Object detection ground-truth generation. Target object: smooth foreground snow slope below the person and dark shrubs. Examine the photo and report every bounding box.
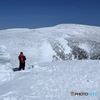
[0,60,100,100]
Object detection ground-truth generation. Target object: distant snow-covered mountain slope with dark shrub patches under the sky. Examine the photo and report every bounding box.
[0,24,100,66]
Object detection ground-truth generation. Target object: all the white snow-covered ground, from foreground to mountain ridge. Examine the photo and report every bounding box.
[0,24,100,100]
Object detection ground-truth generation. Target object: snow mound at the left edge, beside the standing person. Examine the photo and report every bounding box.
[0,45,12,83]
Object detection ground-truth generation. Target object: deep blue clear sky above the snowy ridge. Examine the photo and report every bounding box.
[0,0,100,30]
